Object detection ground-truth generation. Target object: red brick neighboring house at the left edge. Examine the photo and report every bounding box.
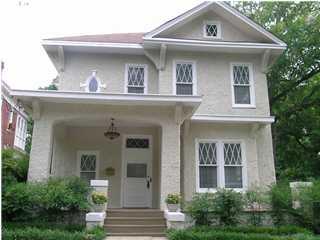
[1,81,28,151]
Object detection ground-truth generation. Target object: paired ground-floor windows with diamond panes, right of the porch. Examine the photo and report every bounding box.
[196,140,246,192]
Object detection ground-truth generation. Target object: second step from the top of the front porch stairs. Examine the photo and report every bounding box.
[105,217,166,226]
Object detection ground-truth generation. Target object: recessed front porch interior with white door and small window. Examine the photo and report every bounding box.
[49,117,162,208]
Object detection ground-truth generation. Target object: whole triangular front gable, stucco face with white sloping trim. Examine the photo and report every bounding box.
[144,2,286,46]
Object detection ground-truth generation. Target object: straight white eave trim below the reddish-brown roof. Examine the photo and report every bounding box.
[42,40,143,49]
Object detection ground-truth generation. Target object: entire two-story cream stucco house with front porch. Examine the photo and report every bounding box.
[11,2,286,209]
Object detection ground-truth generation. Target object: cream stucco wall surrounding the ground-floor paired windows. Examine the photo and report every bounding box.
[182,123,275,201]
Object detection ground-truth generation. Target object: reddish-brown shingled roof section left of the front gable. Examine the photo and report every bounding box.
[44,33,145,44]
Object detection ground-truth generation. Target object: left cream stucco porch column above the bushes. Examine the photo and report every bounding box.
[28,118,53,181]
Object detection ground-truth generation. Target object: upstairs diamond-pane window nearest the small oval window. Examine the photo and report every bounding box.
[125,64,148,94]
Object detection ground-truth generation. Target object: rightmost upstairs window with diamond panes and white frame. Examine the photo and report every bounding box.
[231,63,255,107]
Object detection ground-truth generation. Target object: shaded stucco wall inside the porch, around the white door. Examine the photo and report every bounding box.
[53,123,160,208]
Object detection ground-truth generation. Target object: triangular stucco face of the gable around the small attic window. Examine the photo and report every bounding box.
[159,10,270,42]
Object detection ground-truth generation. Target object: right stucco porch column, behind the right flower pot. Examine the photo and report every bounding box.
[160,122,180,210]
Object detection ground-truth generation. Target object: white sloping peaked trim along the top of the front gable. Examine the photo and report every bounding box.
[143,1,286,46]
